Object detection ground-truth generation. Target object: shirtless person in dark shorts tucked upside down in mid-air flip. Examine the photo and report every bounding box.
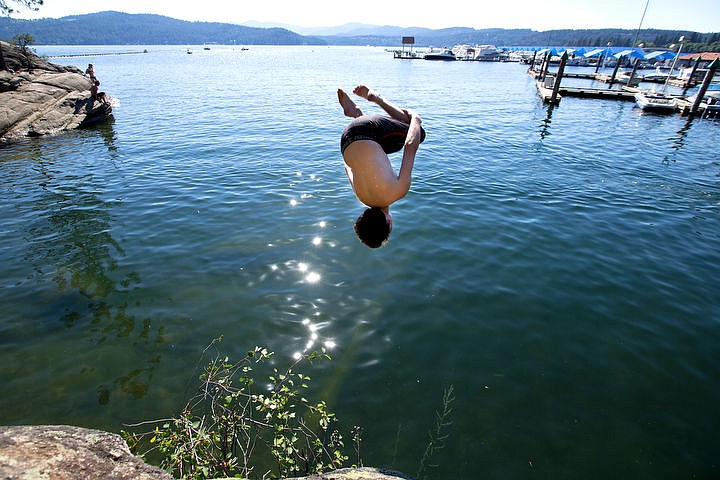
[337,85,425,248]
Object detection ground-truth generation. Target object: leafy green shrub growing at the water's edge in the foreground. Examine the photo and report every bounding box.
[122,339,360,479]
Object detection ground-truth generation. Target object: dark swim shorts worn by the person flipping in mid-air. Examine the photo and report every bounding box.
[340,115,425,153]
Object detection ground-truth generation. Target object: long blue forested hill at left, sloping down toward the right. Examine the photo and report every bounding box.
[0,12,325,45]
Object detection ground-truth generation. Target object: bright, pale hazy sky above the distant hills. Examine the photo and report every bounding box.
[13,0,720,32]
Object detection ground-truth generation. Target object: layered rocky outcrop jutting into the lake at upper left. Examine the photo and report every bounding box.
[0,42,112,143]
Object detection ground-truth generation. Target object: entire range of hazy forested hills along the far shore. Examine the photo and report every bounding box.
[0,12,720,51]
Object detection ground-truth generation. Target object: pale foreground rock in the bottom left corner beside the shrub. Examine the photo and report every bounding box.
[0,425,172,480]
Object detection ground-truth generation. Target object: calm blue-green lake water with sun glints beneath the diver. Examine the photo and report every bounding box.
[0,46,720,479]
